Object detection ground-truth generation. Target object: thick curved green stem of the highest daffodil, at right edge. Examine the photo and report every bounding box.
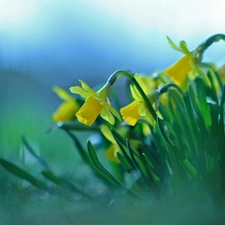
[193,34,225,63]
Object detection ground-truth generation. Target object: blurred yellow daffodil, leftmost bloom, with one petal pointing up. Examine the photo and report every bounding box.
[52,86,80,122]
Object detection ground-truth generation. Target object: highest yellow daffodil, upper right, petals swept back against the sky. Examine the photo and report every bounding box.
[164,37,196,86]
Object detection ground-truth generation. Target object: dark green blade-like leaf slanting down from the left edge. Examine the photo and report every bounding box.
[0,158,48,190]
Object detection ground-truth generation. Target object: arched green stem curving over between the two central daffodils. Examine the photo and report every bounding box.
[106,70,157,120]
